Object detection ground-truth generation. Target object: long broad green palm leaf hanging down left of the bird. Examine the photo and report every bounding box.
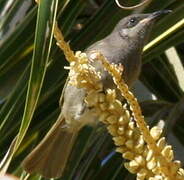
[15,0,58,150]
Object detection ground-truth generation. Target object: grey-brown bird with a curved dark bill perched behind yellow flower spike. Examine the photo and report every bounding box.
[22,10,170,178]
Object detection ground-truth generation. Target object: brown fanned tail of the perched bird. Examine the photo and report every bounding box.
[22,117,77,178]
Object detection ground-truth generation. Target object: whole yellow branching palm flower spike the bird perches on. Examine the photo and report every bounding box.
[55,25,184,180]
